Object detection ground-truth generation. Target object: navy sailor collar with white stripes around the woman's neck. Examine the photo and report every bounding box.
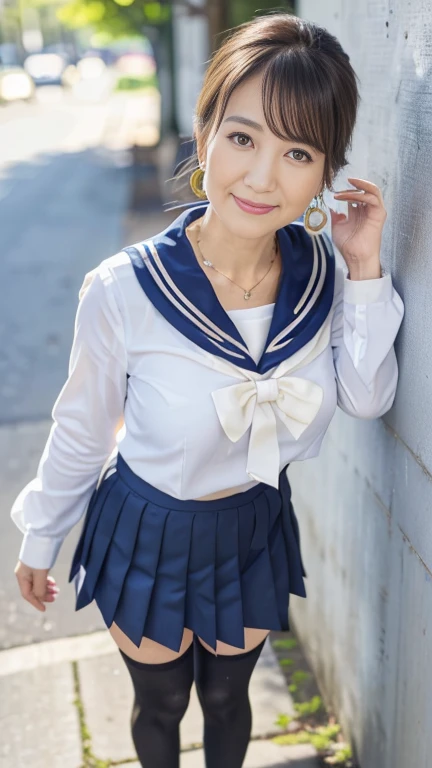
[123,201,335,374]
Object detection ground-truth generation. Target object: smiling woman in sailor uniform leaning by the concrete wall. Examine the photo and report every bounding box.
[12,14,403,768]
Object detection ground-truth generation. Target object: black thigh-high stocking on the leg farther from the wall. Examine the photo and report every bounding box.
[120,643,194,768]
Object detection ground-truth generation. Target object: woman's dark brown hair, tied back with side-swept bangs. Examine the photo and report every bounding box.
[177,13,360,195]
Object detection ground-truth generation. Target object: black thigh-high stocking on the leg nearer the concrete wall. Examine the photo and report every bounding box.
[194,638,265,768]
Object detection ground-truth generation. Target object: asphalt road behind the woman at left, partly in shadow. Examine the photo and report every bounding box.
[0,82,135,648]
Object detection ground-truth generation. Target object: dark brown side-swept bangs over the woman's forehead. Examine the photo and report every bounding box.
[262,49,335,155]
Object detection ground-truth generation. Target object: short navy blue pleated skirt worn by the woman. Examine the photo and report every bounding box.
[69,455,306,652]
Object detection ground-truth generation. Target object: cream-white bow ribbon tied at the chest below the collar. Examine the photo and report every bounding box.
[212,376,323,488]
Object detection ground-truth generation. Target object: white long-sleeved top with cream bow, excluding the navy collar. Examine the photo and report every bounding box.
[12,225,404,568]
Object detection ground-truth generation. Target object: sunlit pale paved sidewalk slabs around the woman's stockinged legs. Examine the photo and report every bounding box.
[0,631,319,768]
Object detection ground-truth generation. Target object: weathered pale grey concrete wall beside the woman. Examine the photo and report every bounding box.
[289,0,432,768]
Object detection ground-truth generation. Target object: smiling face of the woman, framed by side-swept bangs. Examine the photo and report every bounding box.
[198,75,325,238]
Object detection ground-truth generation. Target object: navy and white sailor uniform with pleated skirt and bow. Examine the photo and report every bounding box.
[12,202,404,651]
